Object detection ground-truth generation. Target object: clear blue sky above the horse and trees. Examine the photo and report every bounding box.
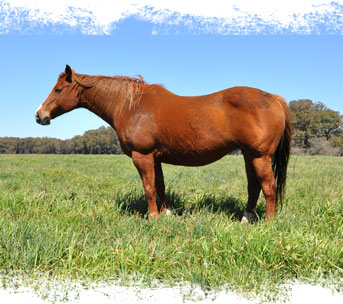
[0,0,343,138]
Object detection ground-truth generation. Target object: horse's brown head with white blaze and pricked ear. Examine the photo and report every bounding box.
[35,65,80,125]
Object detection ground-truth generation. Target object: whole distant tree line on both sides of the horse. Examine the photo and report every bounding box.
[0,99,343,156]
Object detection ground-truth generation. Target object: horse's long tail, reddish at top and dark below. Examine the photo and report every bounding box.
[272,96,292,206]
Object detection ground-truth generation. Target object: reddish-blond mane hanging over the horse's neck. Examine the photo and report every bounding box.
[73,73,146,113]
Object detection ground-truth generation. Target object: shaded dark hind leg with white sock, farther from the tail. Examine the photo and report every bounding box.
[241,153,261,223]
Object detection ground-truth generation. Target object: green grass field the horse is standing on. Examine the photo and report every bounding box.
[0,155,343,296]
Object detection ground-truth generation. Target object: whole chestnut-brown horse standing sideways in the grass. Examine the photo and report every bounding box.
[35,65,291,222]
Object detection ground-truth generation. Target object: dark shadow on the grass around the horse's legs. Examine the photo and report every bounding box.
[116,191,265,220]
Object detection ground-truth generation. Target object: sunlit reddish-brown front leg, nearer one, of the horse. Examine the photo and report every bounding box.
[131,152,158,218]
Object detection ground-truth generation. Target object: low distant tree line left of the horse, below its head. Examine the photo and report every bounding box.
[0,127,122,154]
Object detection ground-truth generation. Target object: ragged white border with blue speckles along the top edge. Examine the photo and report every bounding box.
[0,0,343,34]
